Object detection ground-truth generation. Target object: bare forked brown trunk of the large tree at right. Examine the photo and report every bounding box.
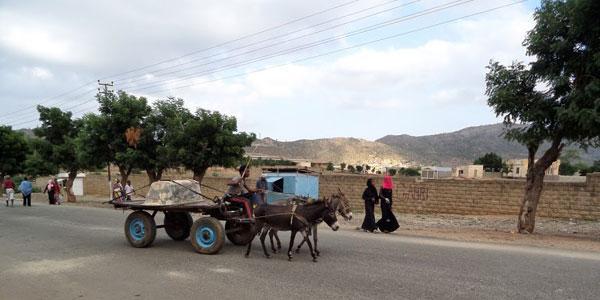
[517,139,564,233]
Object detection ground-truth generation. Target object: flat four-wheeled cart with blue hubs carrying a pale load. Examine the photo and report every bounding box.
[110,180,256,254]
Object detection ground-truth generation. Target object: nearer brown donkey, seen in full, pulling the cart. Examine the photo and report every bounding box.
[246,200,339,262]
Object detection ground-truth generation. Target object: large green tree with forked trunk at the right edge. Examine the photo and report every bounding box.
[486,0,600,232]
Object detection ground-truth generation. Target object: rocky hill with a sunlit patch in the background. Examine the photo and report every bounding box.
[248,124,600,166]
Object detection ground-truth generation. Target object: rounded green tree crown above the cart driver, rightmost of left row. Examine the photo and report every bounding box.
[174,109,256,182]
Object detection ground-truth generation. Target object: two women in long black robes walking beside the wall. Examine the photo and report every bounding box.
[361,175,400,233]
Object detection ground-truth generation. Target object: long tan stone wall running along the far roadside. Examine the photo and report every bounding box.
[84,174,600,219]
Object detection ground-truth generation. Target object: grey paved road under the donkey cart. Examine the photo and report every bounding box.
[0,204,600,299]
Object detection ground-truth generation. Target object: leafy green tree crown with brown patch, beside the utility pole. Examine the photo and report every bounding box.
[78,91,151,182]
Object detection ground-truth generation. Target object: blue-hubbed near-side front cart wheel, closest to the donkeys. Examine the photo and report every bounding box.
[190,217,225,254]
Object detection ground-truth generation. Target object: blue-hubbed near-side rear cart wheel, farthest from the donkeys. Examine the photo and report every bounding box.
[125,211,156,248]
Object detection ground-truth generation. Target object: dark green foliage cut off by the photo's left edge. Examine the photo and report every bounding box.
[0,126,30,177]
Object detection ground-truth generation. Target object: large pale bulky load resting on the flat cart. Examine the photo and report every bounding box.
[144,180,206,205]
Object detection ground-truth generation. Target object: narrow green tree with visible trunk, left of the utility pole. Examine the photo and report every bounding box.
[33,105,88,202]
